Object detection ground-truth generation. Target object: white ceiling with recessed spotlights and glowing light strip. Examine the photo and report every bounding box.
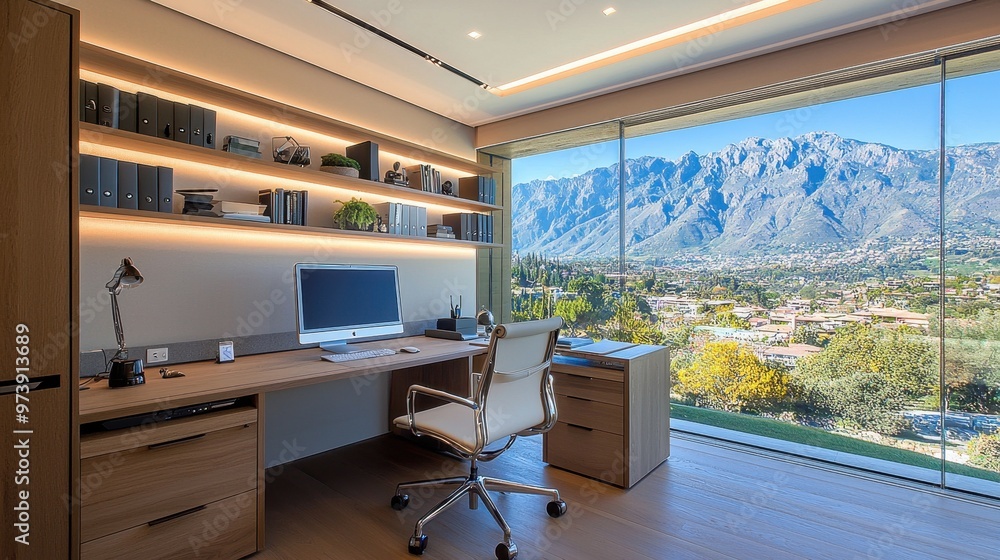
[146,0,966,126]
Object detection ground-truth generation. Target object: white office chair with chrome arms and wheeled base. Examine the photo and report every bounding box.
[391,317,566,560]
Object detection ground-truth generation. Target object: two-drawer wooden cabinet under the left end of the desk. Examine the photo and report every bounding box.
[79,406,259,560]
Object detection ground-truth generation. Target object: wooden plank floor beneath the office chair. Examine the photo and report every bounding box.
[253,435,1000,560]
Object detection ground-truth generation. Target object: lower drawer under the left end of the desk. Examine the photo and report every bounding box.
[80,491,257,560]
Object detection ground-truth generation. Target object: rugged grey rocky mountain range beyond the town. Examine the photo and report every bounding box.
[511,132,1000,257]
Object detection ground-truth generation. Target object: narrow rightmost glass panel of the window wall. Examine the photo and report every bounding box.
[939,51,1000,496]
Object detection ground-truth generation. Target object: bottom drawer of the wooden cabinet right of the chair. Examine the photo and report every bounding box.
[545,422,626,486]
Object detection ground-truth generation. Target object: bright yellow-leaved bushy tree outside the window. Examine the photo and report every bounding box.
[676,341,788,412]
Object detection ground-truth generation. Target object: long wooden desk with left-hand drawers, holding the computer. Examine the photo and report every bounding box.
[74,336,486,560]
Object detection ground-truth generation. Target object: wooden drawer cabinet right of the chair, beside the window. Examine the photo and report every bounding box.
[543,345,670,488]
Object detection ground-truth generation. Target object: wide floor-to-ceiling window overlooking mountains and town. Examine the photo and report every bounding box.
[494,43,1000,496]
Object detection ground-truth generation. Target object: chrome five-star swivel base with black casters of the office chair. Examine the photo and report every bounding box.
[390,468,566,560]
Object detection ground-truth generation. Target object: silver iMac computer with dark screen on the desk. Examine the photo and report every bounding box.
[295,263,403,354]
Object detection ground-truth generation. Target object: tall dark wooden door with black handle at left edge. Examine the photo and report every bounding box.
[0,0,79,559]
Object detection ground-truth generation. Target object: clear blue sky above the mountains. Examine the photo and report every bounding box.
[512,72,1000,184]
